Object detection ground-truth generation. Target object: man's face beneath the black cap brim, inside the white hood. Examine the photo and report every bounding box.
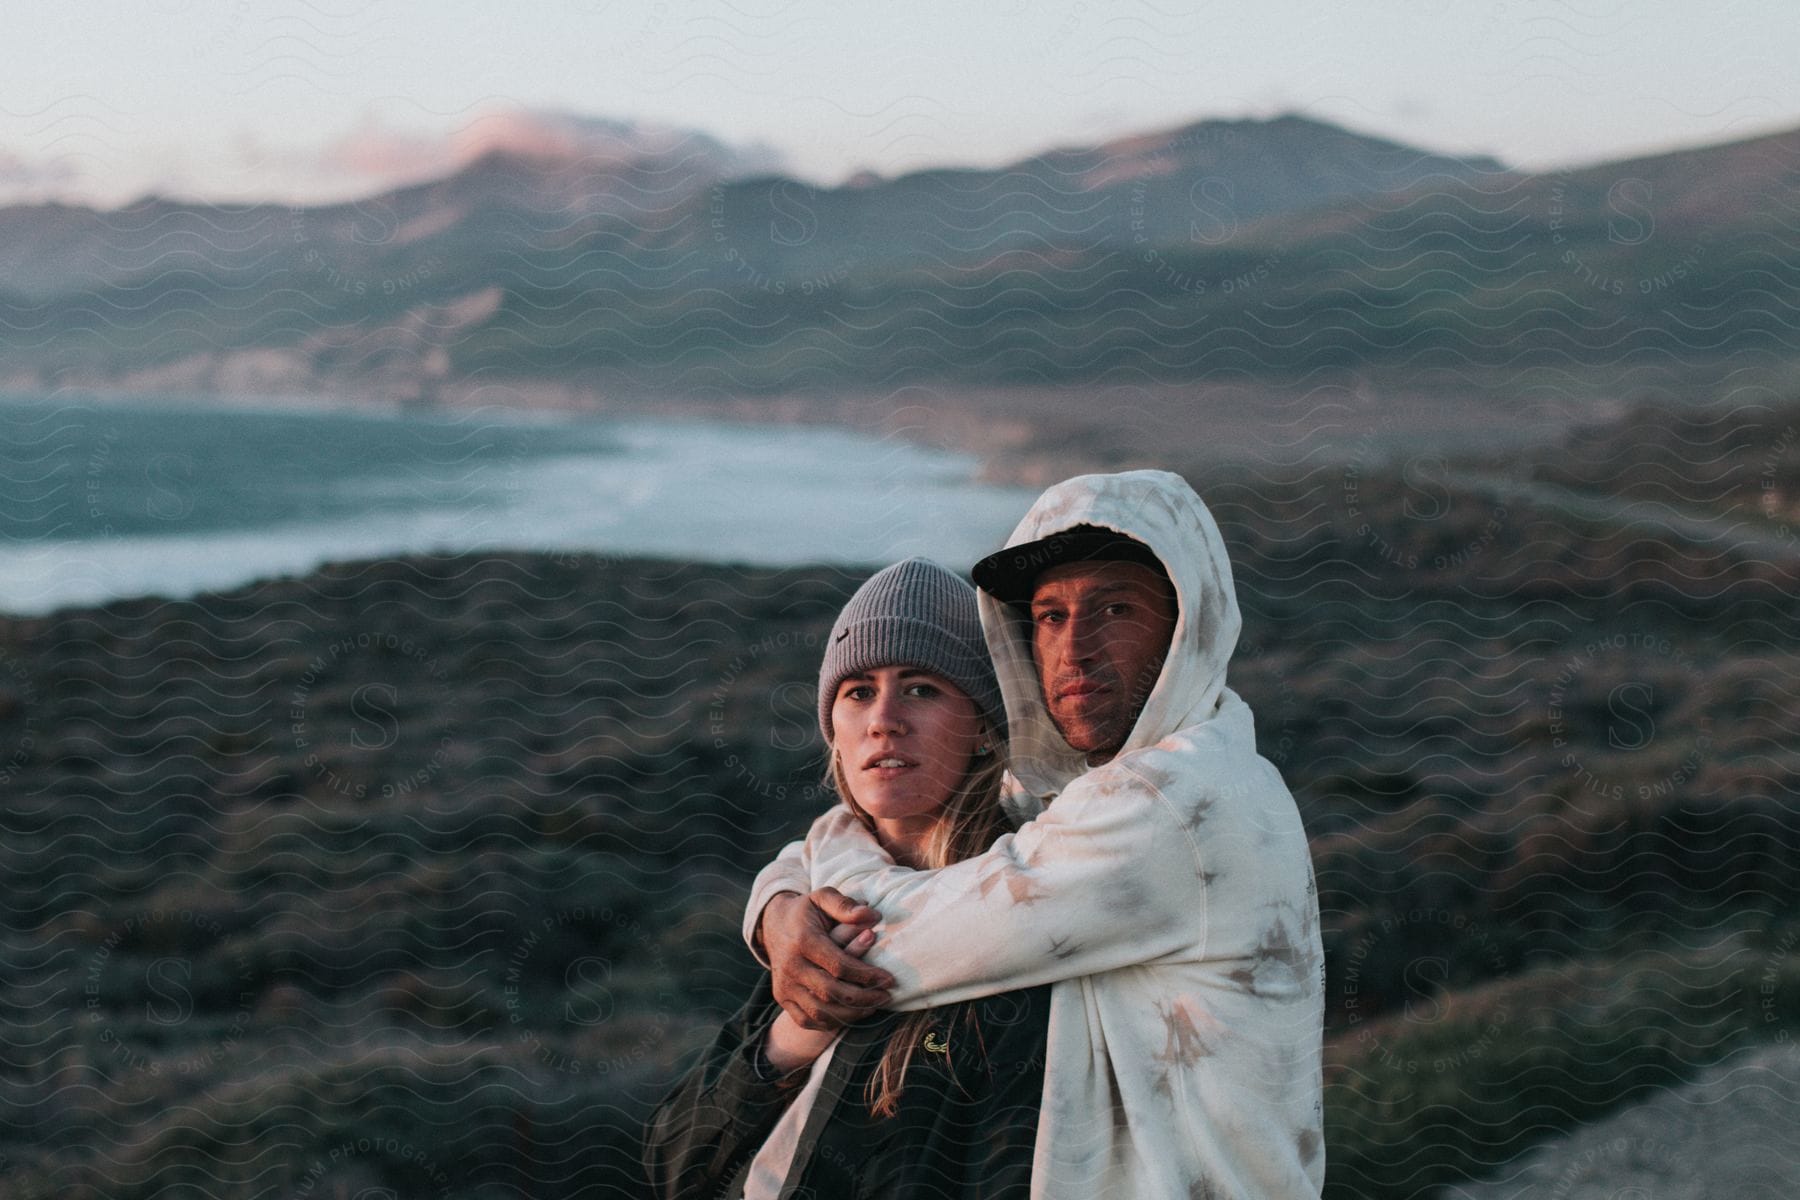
[1031,561,1175,765]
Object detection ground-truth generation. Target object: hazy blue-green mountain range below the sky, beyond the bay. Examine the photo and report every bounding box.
[0,115,1800,394]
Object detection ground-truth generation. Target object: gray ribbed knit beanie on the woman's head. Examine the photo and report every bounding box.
[819,558,1006,745]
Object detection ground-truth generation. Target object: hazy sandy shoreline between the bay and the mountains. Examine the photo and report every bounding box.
[11,371,1618,488]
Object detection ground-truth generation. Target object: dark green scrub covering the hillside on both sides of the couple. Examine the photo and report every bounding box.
[0,402,1800,1200]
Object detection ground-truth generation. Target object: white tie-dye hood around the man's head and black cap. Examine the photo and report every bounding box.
[981,471,1242,797]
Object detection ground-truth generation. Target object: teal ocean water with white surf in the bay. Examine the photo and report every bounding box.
[0,396,1035,613]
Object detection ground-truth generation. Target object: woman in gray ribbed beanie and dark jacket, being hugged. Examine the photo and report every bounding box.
[644,558,1049,1200]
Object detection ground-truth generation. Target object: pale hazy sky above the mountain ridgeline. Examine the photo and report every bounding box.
[0,0,1800,201]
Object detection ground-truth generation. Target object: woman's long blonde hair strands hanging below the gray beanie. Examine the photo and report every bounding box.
[828,727,1013,1117]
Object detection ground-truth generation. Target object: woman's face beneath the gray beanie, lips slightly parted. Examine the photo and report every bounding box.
[832,667,981,822]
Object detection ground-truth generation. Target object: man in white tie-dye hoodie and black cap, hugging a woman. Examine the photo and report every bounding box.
[745,471,1325,1200]
